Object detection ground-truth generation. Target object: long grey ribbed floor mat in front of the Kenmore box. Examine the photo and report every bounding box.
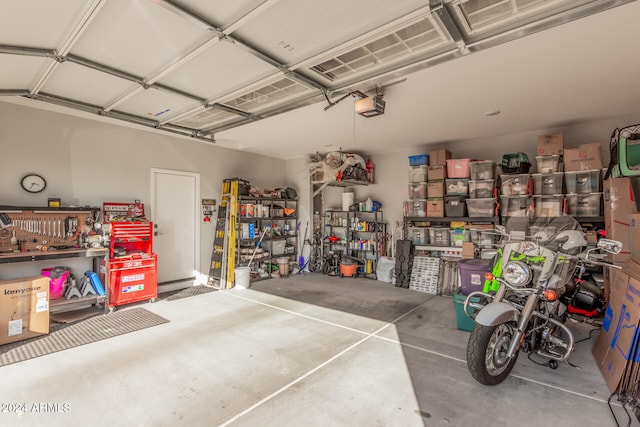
[0,307,169,366]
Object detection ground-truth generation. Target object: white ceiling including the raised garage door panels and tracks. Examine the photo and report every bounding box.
[0,0,640,158]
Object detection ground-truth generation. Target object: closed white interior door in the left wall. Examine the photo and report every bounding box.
[151,169,200,283]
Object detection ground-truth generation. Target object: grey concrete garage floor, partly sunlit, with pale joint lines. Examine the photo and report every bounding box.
[0,274,638,427]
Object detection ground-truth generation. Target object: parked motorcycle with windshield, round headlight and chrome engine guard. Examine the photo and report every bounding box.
[464,216,622,385]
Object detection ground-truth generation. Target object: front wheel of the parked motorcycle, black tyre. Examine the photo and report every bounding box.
[467,322,518,385]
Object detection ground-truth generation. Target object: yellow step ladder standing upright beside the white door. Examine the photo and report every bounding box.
[208,178,249,289]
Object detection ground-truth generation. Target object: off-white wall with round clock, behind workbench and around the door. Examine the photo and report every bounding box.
[0,102,300,279]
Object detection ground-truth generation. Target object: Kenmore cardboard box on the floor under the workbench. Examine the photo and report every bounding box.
[0,276,49,344]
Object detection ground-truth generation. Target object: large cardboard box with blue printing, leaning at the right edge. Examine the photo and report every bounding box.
[592,261,640,392]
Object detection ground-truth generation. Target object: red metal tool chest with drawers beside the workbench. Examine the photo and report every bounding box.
[100,222,158,307]
